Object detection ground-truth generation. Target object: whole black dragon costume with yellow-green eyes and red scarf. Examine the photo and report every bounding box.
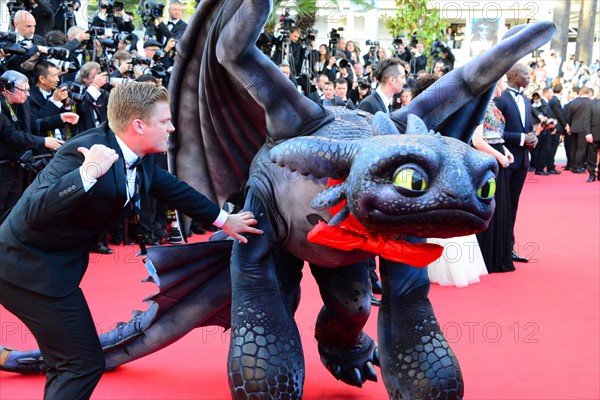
[0,0,555,399]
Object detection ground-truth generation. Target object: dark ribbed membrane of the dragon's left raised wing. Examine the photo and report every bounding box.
[169,1,265,205]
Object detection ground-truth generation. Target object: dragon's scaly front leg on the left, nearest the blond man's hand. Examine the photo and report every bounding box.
[228,191,304,399]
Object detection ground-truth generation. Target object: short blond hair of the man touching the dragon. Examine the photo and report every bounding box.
[107,82,169,133]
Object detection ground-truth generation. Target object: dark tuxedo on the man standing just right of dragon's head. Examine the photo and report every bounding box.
[494,89,533,246]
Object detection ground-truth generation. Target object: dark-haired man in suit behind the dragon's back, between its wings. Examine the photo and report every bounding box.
[358,58,406,114]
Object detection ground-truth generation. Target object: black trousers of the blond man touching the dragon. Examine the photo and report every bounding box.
[0,279,105,400]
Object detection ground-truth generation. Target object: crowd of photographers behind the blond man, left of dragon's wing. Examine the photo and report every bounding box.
[0,0,189,254]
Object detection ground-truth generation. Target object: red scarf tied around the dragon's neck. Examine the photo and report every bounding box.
[307,221,444,268]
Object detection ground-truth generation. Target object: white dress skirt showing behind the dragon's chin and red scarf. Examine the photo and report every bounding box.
[427,235,488,287]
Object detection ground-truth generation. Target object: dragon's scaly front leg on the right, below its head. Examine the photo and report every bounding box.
[378,239,464,399]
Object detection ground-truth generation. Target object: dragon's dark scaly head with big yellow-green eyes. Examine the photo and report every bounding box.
[271,116,498,238]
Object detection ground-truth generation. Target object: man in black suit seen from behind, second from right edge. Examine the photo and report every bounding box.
[567,86,592,174]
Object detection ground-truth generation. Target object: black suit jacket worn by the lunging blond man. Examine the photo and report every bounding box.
[0,125,220,297]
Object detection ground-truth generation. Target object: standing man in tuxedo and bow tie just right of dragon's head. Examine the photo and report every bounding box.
[494,64,544,262]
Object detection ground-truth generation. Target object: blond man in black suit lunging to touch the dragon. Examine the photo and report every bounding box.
[0,83,262,400]
